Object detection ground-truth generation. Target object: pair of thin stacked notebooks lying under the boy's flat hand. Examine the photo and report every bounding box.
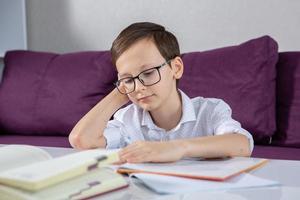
[117,157,279,193]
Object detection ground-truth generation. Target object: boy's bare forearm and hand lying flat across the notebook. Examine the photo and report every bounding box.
[119,133,251,163]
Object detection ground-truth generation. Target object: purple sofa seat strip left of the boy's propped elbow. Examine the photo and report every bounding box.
[0,134,71,147]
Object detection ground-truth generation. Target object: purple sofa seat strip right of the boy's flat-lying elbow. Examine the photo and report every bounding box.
[252,145,300,160]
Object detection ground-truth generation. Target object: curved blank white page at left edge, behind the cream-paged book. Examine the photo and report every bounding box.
[0,145,51,172]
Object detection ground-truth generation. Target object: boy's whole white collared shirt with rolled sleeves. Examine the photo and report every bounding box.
[104,90,253,152]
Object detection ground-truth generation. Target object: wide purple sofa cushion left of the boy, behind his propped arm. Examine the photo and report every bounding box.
[0,51,117,135]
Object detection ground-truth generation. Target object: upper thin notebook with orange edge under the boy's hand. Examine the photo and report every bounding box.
[117,157,268,181]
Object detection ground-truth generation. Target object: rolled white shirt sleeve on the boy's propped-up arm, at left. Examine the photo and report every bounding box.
[103,119,126,149]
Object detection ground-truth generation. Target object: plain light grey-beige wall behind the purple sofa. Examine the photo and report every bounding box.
[27,0,300,52]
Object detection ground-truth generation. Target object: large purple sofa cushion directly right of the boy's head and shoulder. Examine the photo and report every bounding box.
[179,36,278,143]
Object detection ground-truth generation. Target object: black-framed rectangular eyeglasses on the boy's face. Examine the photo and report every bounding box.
[115,60,171,94]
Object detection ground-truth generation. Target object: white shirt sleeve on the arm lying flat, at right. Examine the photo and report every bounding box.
[212,100,254,153]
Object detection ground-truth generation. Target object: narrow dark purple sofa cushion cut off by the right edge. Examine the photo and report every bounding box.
[273,52,300,147]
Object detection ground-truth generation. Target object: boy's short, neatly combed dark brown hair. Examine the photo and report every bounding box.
[110,22,180,65]
